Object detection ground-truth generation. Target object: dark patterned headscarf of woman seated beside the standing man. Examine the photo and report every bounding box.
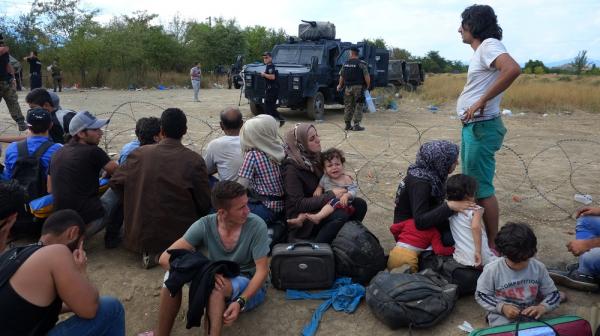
[407,140,459,198]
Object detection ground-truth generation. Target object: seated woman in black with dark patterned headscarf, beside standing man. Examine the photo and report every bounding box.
[391,140,475,246]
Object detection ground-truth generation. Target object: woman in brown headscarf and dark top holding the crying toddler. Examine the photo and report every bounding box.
[283,123,367,243]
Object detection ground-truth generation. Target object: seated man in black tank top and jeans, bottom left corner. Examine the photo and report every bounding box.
[0,210,125,336]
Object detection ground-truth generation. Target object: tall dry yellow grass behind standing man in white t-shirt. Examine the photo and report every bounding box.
[418,74,600,113]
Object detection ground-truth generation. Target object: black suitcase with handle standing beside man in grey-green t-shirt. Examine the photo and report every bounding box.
[271,242,335,289]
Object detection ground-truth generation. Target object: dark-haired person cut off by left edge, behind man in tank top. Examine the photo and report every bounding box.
[0,180,25,254]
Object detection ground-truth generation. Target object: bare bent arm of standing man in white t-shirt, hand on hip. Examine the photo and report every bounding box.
[465,53,521,121]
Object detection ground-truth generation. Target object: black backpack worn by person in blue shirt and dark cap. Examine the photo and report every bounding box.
[11,139,54,200]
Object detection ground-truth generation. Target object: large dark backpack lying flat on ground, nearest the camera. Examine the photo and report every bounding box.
[366,269,458,329]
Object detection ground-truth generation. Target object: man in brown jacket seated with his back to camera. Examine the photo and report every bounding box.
[110,108,210,268]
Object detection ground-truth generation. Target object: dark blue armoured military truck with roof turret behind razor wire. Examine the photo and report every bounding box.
[243,21,389,119]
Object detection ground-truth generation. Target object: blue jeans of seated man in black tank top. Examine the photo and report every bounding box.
[48,296,125,336]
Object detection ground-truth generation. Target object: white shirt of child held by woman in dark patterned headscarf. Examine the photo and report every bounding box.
[450,206,497,266]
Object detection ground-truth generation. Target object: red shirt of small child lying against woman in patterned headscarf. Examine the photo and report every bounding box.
[390,218,454,256]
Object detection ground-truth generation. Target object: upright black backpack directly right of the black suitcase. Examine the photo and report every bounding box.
[331,221,386,285]
